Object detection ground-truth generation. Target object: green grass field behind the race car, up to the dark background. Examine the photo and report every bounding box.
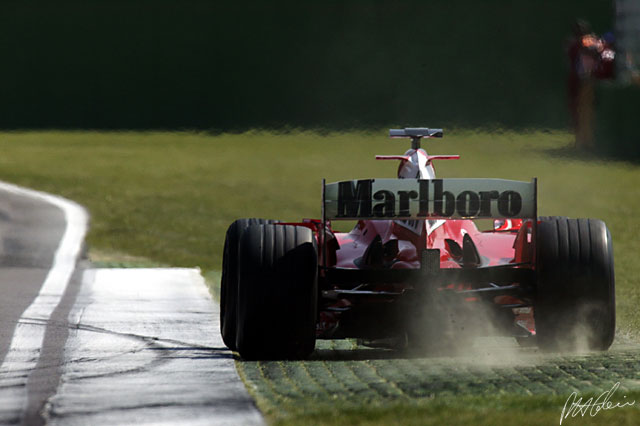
[0,130,640,330]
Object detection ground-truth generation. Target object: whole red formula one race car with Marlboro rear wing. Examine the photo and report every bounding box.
[220,128,615,359]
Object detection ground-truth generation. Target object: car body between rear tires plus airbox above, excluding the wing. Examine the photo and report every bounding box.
[278,130,536,339]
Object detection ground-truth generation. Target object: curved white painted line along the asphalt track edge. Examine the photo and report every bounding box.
[0,182,89,410]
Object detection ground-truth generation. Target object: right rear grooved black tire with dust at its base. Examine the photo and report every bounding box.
[534,218,616,351]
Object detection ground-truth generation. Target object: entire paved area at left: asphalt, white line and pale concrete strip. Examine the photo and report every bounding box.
[0,182,263,425]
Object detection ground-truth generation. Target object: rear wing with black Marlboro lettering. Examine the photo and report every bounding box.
[322,178,537,223]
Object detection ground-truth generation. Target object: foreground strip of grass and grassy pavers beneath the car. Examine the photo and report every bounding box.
[238,339,640,425]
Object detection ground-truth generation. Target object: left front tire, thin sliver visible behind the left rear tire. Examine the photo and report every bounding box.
[220,219,274,350]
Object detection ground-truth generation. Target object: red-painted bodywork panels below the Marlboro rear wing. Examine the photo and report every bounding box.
[288,215,535,338]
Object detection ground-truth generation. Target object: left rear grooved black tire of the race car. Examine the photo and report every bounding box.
[236,224,318,359]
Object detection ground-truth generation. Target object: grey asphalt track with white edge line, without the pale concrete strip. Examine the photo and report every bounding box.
[0,183,80,424]
